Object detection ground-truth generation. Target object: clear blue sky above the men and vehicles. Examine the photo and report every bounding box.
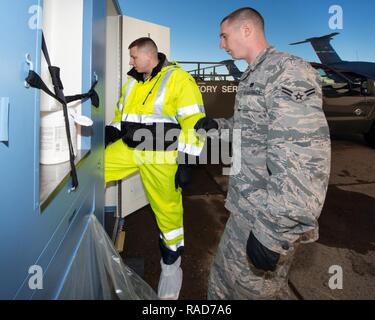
[119,0,375,70]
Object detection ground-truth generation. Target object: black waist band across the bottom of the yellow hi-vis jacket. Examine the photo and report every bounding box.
[121,122,181,151]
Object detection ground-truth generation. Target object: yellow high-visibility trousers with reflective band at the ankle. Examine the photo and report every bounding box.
[104,139,184,251]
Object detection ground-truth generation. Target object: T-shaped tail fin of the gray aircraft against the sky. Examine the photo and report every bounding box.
[290,32,342,65]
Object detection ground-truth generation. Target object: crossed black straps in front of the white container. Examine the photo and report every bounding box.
[26,33,99,190]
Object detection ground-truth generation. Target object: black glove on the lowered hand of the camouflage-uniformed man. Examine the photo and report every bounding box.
[246,232,280,271]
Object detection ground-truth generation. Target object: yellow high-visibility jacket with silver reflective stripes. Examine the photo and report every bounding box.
[111,58,205,156]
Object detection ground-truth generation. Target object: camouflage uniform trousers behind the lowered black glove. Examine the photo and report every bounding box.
[207,213,298,300]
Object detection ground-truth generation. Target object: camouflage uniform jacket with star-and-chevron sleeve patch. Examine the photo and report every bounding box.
[216,47,331,254]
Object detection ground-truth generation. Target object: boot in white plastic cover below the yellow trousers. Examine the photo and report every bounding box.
[158,257,182,300]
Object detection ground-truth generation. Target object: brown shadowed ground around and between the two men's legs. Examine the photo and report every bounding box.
[122,136,375,300]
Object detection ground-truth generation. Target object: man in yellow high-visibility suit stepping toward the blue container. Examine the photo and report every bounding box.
[105,38,205,299]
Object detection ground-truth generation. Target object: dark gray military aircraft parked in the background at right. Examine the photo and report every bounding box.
[290,32,375,79]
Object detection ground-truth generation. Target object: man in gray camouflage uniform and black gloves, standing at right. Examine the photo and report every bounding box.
[195,8,330,299]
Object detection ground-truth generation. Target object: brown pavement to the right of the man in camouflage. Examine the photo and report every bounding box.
[290,136,375,300]
